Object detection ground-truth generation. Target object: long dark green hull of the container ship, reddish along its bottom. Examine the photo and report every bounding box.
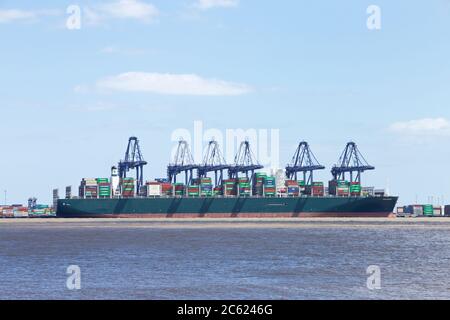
[56,197,398,218]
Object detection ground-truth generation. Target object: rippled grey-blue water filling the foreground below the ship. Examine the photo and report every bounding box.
[0,219,450,299]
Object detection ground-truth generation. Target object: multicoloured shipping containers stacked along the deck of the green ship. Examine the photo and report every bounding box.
[73,172,380,198]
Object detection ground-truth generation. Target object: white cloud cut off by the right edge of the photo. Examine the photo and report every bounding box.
[389,118,450,136]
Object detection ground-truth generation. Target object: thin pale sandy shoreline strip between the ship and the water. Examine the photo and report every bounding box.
[0,217,450,229]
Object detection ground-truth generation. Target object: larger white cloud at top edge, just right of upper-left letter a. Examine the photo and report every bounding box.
[83,0,159,24]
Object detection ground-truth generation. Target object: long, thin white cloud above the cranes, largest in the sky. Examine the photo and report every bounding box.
[96,72,252,96]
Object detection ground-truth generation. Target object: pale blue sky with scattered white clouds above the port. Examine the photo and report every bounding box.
[0,0,450,204]
